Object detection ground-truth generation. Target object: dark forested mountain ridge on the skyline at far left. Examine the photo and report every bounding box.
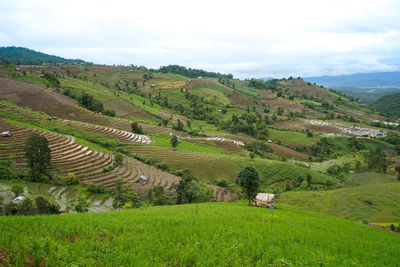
[0,46,87,64]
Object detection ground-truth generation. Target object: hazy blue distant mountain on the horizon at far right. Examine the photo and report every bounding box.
[304,71,400,91]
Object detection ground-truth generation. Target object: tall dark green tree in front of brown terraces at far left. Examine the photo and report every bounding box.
[25,134,51,181]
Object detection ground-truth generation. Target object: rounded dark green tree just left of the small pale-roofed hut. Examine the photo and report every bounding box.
[236,166,261,206]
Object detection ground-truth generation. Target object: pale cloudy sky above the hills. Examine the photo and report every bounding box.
[0,0,400,78]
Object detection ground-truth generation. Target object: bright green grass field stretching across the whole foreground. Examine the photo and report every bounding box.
[0,203,400,266]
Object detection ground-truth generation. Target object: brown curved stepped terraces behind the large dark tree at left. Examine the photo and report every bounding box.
[0,121,178,194]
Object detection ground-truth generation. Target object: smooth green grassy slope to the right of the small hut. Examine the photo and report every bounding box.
[277,183,400,222]
